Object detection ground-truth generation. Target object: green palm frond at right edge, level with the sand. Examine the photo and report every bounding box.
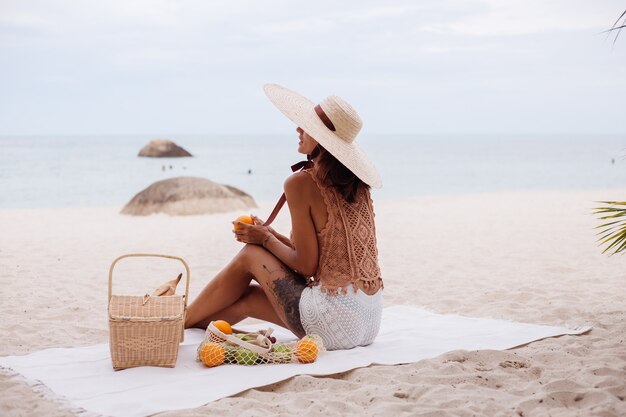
[593,201,626,255]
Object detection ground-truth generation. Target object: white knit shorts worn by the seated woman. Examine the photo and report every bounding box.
[300,285,383,350]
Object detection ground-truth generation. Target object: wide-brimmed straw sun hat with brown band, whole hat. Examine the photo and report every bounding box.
[263,84,383,188]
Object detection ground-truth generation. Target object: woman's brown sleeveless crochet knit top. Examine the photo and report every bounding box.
[303,169,383,295]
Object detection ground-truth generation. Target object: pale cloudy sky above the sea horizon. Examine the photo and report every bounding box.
[0,0,626,135]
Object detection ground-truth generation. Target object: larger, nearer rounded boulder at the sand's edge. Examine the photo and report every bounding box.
[121,177,257,216]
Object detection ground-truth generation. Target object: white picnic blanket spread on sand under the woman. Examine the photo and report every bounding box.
[0,305,591,417]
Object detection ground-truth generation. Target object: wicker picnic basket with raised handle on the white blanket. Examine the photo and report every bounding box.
[109,253,189,370]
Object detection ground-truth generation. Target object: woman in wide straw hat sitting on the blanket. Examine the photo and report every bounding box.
[185,84,383,350]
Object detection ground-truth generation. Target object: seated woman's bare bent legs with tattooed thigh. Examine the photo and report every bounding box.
[185,244,306,337]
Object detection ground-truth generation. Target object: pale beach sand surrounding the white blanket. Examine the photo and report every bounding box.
[0,190,626,417]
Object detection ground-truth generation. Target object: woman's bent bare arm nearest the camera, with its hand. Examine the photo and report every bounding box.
[235,173,318,276]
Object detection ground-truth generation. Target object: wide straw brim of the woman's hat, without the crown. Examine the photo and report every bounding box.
[263,84,382,188]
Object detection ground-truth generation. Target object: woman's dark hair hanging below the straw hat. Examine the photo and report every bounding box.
[311,144,370,203]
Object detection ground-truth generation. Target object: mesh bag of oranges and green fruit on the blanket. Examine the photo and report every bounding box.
[196,320,325,367]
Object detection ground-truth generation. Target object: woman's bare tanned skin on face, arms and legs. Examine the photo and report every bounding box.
[185,128,327,337]
